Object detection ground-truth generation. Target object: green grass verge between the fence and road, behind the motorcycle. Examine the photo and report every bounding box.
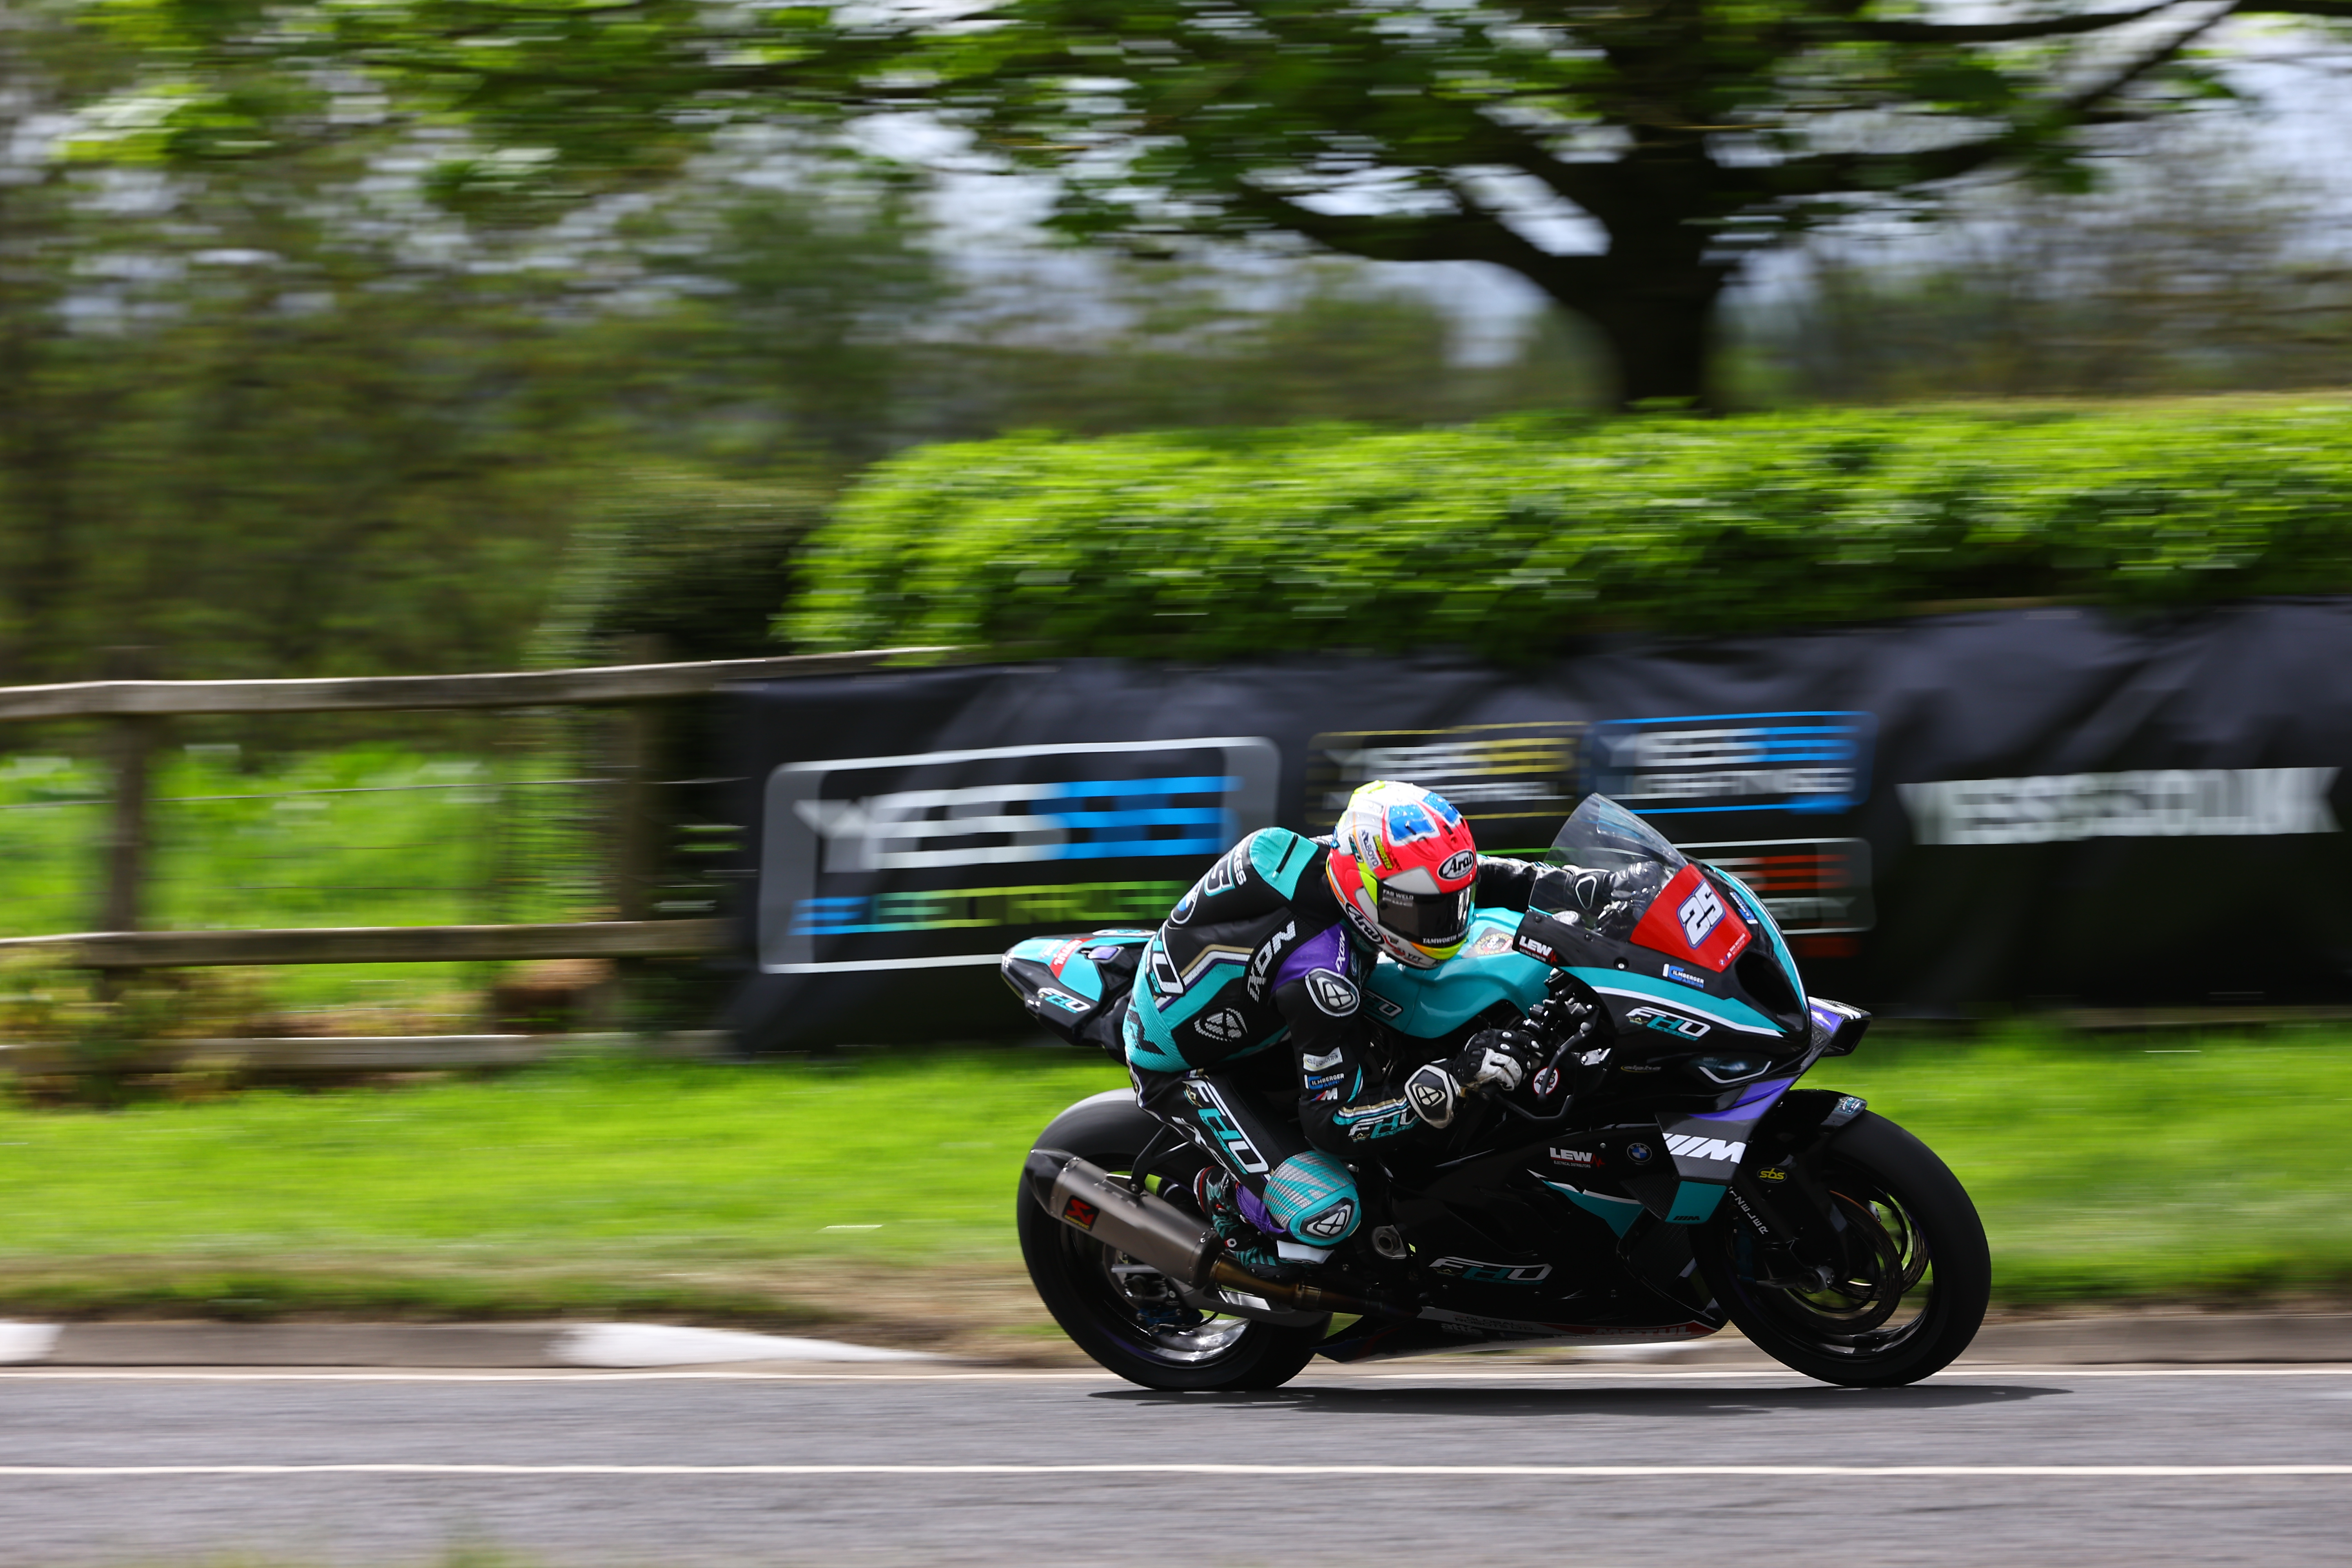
[0,1032,2352,1340]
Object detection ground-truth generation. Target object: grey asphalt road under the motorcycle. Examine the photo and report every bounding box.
[0,1361,2352,1568]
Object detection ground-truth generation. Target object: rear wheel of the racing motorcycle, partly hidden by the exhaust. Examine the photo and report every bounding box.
[1014,1091,1331,1389]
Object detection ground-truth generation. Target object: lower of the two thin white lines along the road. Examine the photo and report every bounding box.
[0,1462,2352,1481]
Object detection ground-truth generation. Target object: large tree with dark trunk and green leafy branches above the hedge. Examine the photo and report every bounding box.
[83,0,2352,402]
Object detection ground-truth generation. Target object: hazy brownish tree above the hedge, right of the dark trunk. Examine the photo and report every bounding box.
[1740,122,2352,402]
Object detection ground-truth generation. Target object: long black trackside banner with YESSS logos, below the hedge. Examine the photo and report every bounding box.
[722,599,2352,1049]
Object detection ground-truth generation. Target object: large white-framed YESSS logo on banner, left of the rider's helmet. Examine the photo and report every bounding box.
[757,736,1282,973]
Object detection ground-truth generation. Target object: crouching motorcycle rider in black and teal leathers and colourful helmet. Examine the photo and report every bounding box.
[1120,780,1548,1272]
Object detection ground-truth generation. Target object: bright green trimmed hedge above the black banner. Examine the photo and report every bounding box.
[779,399,2352,661]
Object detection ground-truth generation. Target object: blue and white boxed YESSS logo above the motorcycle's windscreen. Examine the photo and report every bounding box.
[1590,712,1877,816]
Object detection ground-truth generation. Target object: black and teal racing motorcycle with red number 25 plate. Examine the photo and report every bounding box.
[1002,795,1992,1389]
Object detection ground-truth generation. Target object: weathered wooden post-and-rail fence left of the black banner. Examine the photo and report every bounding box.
[0,649,948,1065]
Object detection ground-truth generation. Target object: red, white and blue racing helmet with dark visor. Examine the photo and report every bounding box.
[1324,778,1477,969]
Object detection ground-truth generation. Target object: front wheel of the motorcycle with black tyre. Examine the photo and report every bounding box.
[1691,1112,1992,1387]
